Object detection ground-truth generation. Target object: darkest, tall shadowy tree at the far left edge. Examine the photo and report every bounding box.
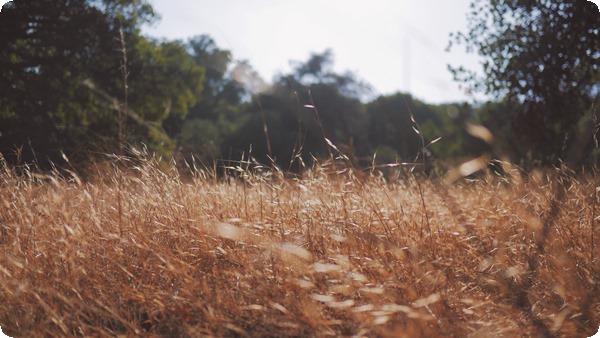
[0,1,118,165]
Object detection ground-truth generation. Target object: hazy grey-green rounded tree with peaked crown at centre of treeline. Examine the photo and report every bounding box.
[221,51,370,170]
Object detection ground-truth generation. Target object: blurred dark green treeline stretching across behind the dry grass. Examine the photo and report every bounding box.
[0,0,598,171]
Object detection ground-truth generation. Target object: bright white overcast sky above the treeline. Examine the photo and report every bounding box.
[144,0,488,103]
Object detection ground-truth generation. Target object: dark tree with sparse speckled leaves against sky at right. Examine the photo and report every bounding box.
[449,0,600,164]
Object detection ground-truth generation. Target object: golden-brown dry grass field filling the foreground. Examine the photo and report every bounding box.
[0,154,600,337]
